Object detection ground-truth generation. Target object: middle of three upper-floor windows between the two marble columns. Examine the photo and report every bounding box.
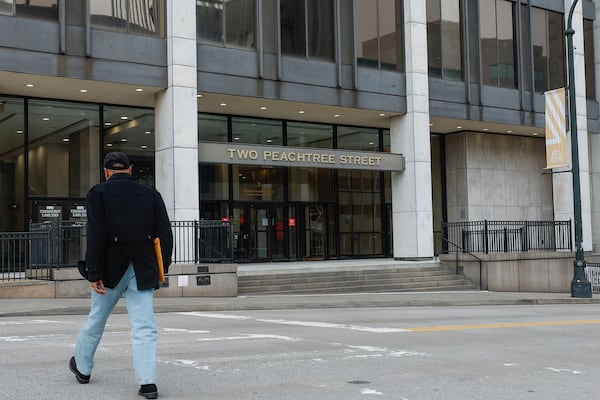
[281,0,334,60]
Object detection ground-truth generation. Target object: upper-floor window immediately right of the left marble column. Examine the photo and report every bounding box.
[196,0,256,49]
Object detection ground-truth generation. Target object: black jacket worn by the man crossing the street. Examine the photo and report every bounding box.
[85,173,173,290]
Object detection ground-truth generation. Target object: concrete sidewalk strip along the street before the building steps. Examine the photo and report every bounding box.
[0,291,600,317]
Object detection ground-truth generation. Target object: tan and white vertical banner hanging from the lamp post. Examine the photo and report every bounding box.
[545,88,576,169]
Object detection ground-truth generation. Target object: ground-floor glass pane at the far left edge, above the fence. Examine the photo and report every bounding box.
[0,96,25,232]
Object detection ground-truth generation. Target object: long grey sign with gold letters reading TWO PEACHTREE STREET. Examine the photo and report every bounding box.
[198,143,404,171]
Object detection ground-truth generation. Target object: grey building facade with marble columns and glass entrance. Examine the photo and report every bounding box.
[0,0,600,262]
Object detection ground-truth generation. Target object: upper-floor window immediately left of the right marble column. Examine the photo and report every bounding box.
[354,0,404,71]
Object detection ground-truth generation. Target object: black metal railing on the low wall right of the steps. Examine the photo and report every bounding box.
[442,220,573,254]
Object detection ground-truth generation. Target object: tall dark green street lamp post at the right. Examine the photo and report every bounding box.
[565,0,592,297]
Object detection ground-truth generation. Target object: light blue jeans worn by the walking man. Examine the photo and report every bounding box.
[75,264,158,385]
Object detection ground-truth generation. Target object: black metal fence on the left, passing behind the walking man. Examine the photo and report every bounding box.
[0,221,233,281]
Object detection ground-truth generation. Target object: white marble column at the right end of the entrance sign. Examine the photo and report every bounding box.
[390,0,433,259]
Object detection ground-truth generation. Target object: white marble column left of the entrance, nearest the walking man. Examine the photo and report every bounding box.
[155,0,199,221]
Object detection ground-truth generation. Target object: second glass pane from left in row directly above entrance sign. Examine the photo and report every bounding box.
[231,117,283,145]
